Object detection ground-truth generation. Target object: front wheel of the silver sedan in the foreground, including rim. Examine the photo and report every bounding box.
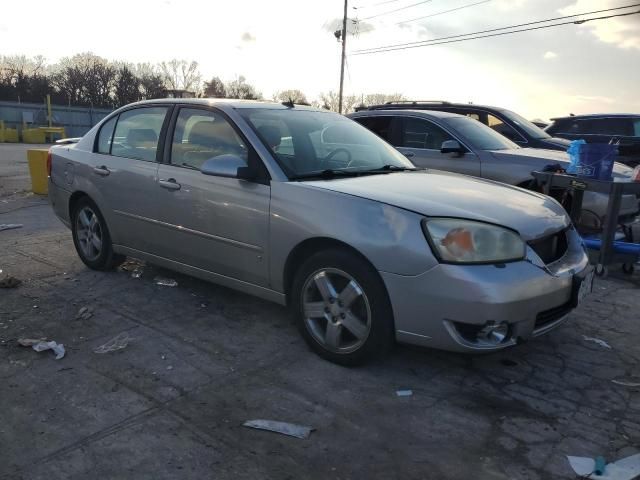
[291,249,395,366]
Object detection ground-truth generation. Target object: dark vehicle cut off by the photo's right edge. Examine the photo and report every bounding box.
[546,113,640,167]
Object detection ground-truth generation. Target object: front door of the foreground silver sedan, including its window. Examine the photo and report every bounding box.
[154,106,271,286]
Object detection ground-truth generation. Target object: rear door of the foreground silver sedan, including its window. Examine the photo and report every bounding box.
[90,105,171,252]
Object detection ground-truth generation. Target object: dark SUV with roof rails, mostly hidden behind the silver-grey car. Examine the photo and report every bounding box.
[356,101,569,151]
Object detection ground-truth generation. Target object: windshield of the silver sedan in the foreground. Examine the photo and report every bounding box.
[238,108,414,179]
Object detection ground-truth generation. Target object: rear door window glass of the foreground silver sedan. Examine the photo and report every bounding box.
[111,107,168,162]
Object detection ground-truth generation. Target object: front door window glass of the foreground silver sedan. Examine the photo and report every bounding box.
[171,108,249,170]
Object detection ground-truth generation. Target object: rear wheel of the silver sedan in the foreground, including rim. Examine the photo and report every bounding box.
[71,197,125,270]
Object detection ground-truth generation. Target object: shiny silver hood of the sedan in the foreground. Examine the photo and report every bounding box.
[304,170,569,240]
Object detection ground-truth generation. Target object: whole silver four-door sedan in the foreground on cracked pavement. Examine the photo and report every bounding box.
[49,99,592,364]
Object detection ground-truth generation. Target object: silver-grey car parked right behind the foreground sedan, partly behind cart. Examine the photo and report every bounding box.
[348,110,639,229]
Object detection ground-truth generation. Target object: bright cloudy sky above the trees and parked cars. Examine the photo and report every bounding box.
[0,0,640,120]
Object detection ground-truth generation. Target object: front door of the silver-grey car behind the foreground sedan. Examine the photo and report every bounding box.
[397,117,480,177]
